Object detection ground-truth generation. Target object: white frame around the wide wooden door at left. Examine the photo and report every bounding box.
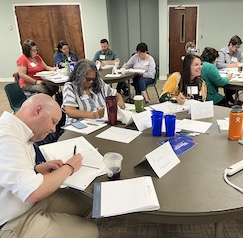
[12,2,87,56]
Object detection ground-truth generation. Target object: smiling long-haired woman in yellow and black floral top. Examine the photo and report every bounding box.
[159,54,207,104]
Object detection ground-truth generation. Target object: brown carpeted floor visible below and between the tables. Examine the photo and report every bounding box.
[0,81,243,238]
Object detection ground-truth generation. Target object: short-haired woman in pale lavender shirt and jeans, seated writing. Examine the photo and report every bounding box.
[122,43,156,104]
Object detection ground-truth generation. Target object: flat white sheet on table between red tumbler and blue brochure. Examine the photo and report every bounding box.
[96,126,142,143]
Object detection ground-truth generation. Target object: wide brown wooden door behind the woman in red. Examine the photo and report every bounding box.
[15,5,85,66]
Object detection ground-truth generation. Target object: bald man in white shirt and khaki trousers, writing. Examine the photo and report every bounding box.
[0,94,98,238]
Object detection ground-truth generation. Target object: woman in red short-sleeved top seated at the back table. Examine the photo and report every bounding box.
[17,40,58,96]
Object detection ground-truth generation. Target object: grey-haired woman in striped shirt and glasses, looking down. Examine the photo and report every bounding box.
[62,59,125,125]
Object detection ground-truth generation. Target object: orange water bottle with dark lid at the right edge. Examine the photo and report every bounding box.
[228,105,243,140]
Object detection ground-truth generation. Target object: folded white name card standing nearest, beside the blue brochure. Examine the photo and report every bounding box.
[135,142,180,178]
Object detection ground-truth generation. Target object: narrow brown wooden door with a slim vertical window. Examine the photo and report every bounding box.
[169,7,197,73]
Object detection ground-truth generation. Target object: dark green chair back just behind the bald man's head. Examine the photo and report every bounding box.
[4,83,27,112]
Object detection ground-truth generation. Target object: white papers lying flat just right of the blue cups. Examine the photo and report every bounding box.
[177,119,212,133]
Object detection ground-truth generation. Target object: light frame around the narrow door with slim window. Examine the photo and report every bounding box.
[166,4,199,74]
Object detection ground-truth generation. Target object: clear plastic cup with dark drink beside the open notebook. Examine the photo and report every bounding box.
[103,152,123,180]
